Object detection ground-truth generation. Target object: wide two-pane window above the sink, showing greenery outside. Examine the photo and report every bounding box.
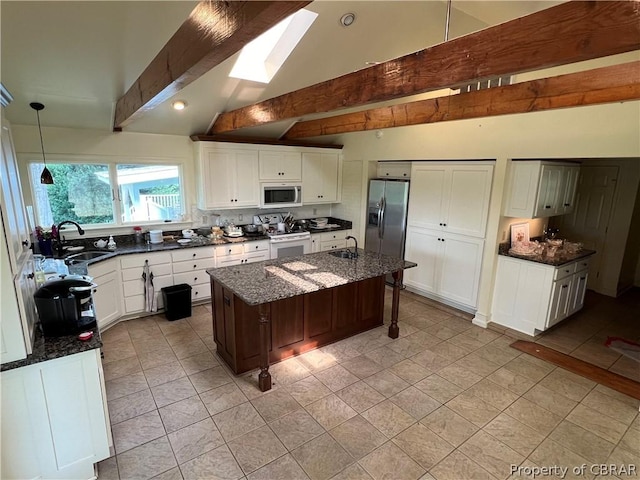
[30,161,184,225]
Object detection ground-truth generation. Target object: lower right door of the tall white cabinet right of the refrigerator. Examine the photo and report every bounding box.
[440,235,484,307]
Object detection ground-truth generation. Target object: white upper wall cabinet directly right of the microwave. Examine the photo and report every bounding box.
[302,152,342,204]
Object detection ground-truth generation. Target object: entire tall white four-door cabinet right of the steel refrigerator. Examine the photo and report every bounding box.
[404,162,493,310]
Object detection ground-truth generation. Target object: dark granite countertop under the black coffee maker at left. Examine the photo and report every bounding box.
[1,325,102,372]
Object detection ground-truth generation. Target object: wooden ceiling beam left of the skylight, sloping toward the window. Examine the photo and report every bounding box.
[114,0,311,130]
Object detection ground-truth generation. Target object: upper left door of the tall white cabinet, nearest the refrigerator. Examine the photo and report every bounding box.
[407,164,448,230]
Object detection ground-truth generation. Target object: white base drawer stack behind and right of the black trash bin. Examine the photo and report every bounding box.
[171,247,216,302]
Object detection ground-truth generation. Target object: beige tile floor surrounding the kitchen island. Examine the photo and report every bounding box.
[99,292,640,480]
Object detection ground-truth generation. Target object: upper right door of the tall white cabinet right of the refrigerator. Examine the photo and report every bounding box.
[444,165,493,238]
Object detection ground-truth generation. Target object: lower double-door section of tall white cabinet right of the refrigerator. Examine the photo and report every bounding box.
[404,227,484,308]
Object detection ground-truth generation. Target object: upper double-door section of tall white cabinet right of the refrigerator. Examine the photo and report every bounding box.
[407,162,493,238]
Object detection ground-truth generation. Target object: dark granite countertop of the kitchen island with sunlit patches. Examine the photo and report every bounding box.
[207,249,417,305]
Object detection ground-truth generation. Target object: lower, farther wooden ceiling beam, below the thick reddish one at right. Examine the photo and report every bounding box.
[284,62,640,140]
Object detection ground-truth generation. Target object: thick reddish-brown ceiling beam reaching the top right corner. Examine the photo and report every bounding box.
[209,0,640,134]
